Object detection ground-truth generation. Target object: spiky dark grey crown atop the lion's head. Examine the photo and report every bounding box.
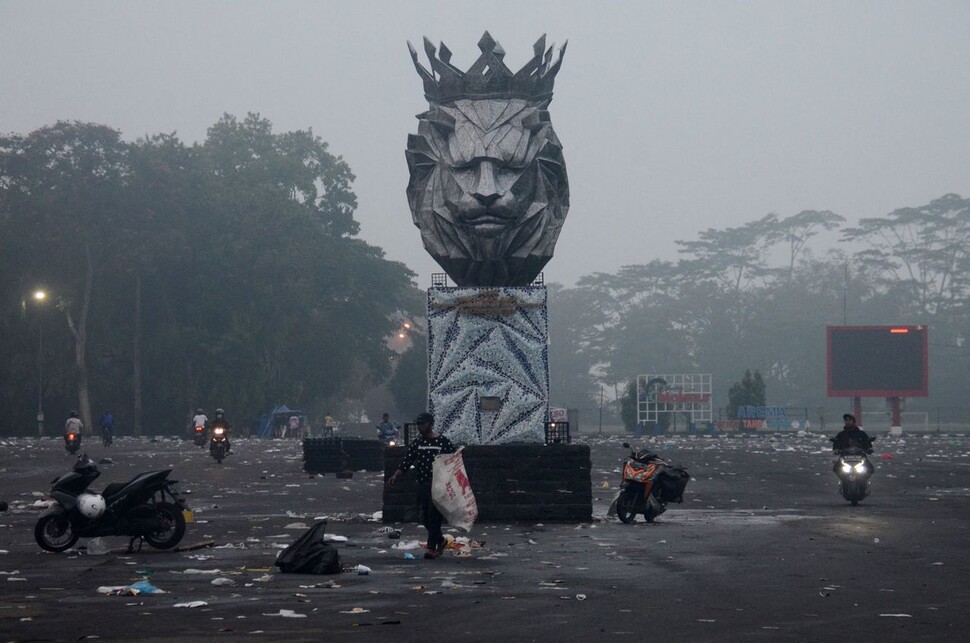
[408,31,566,105]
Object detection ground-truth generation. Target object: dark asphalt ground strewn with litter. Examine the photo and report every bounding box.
[0,434,970,642]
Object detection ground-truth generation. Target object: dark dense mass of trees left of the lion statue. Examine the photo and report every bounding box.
[0,114,423,434]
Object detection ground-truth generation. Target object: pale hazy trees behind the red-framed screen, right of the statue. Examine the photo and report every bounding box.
[549,194,970,428]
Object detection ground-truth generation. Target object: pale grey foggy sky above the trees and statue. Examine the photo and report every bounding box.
[0,0,970,288]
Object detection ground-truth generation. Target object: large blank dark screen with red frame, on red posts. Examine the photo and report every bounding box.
[826,326,929,397]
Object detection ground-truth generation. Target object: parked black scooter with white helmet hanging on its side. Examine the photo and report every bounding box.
[34,453,192,552]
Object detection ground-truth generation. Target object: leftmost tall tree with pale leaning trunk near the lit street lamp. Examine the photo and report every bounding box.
[0,121,127,427]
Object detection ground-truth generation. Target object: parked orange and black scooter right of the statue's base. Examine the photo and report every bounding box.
[615,442,690,523]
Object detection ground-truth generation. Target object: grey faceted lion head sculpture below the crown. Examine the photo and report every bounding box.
[406,33,569,287]
